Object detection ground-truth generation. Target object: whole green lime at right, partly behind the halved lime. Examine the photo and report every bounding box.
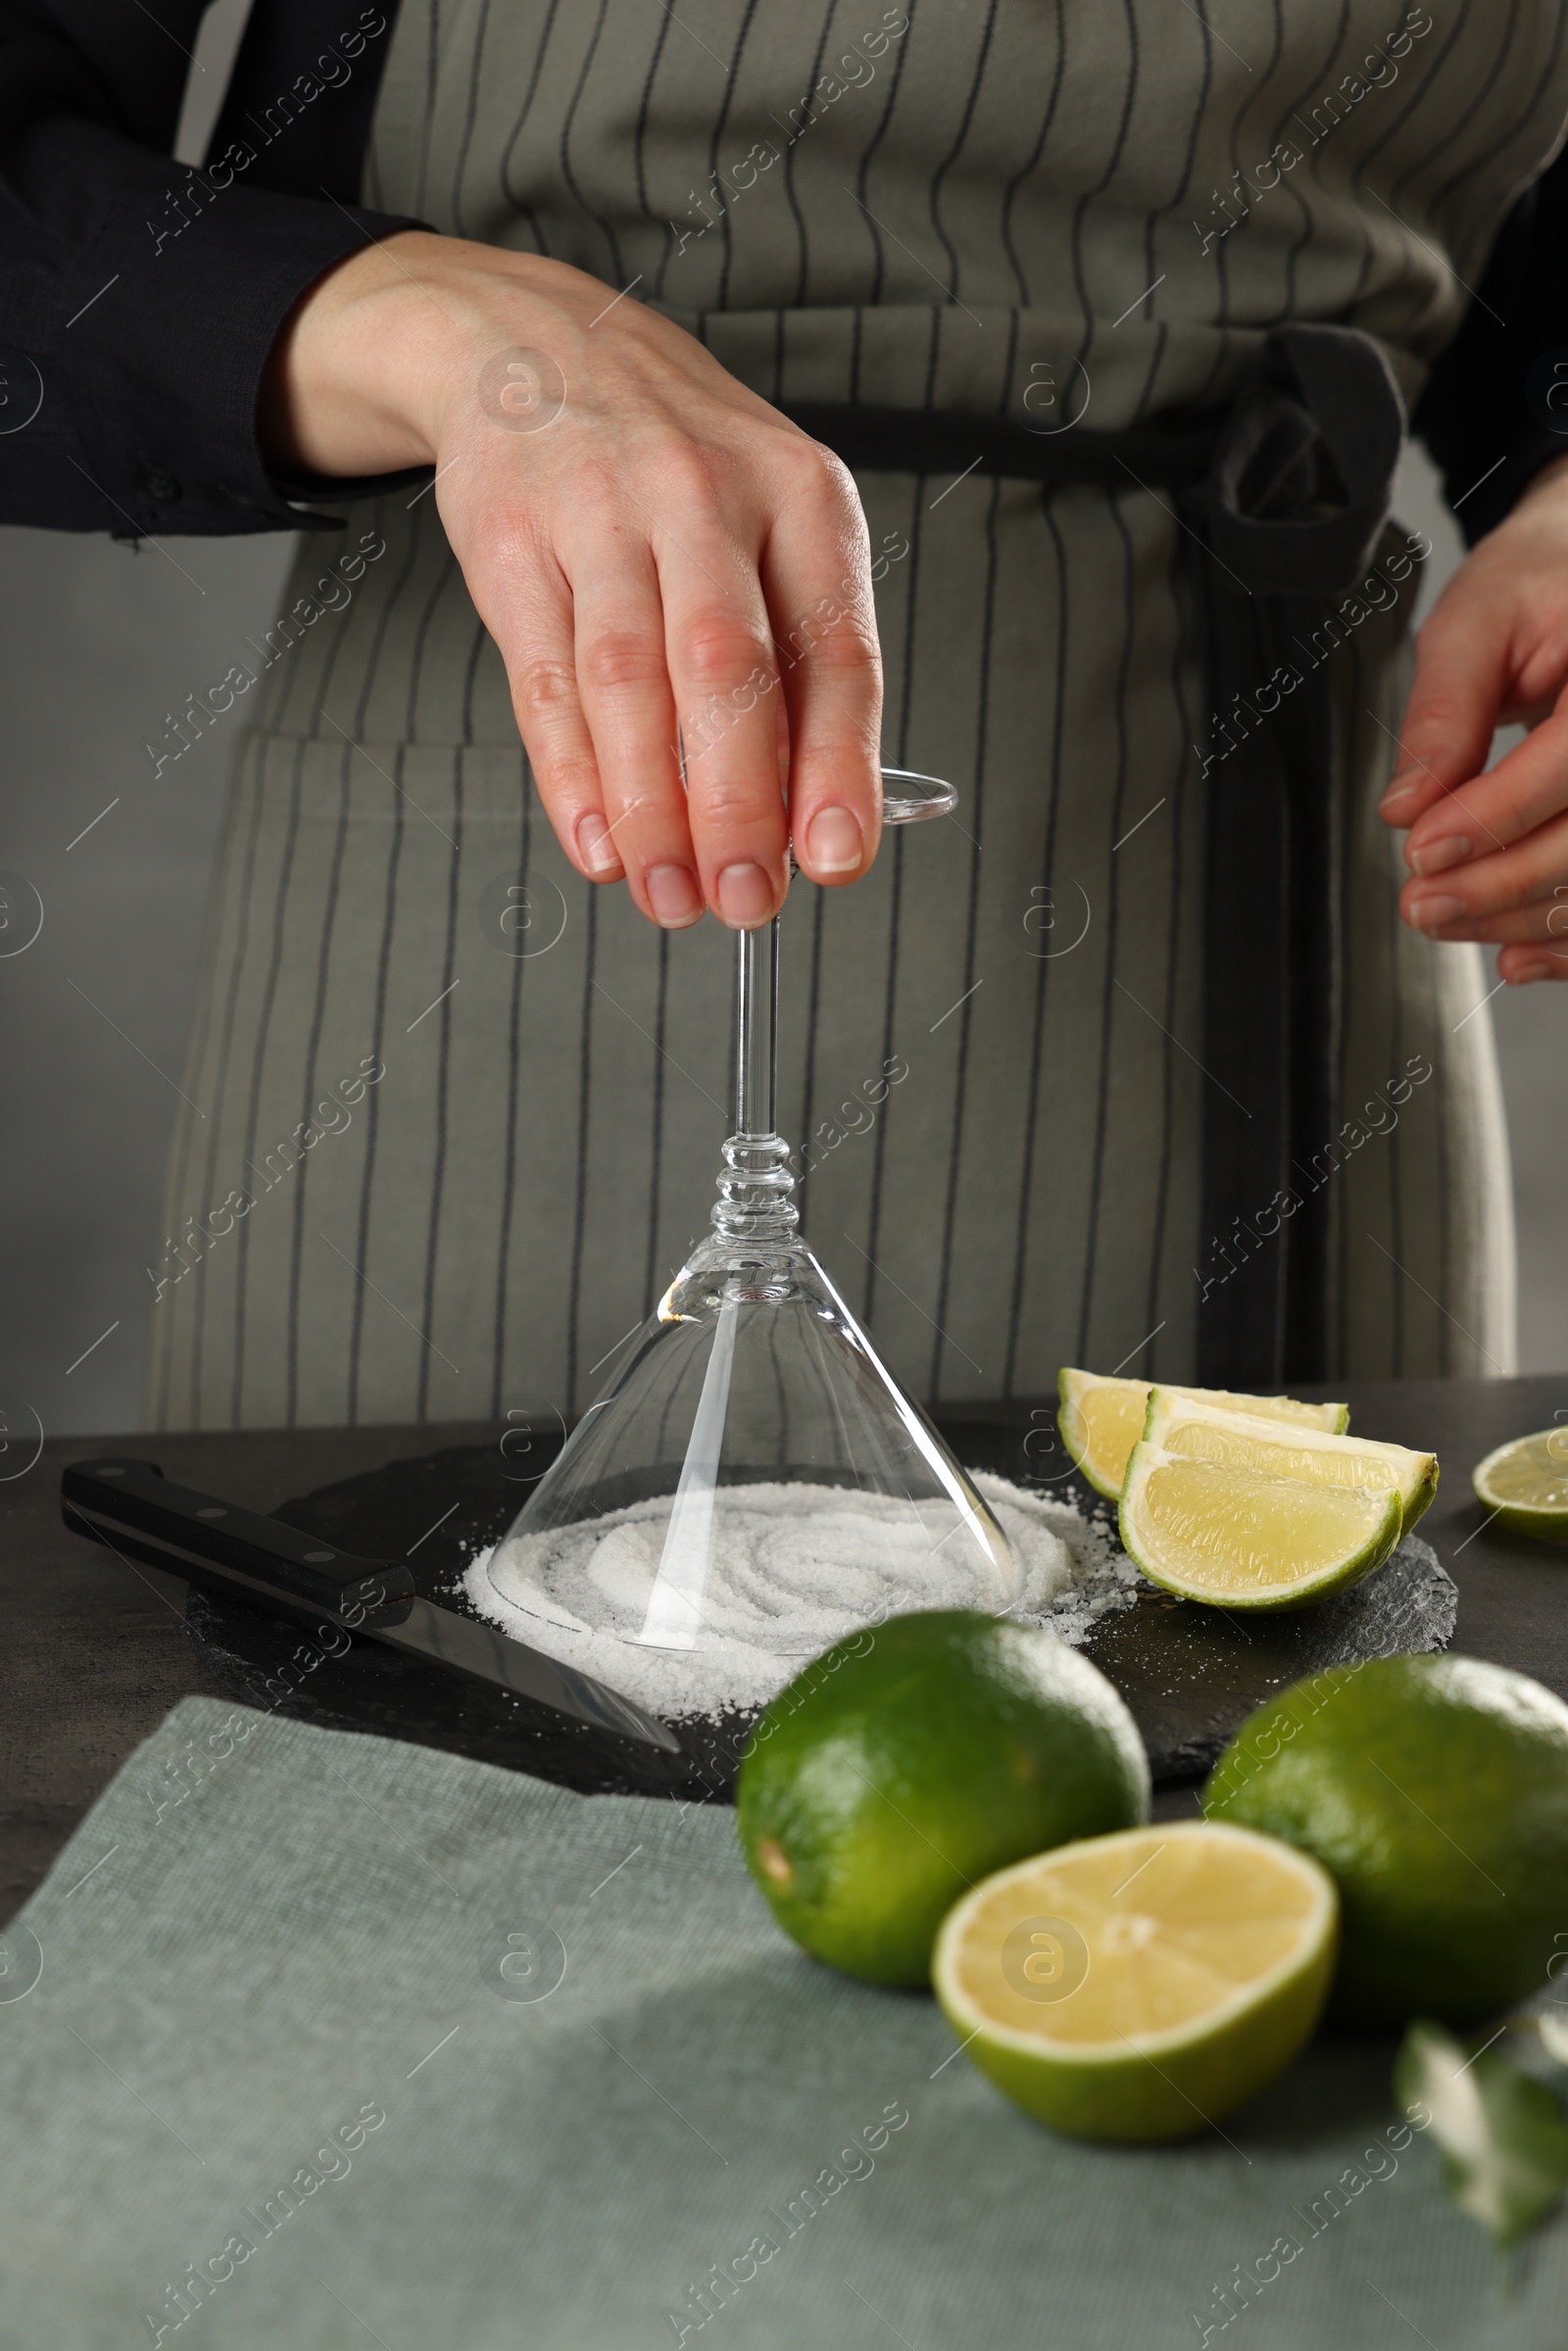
[1203,1657,1568,2025]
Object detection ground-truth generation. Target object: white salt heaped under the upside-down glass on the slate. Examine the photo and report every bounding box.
[464,1472,1136,1721]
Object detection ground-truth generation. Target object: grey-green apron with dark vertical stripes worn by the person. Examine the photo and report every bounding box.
[148,0,1568,1427]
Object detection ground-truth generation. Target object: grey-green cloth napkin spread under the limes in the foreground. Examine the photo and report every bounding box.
[0,1699,1568,2351]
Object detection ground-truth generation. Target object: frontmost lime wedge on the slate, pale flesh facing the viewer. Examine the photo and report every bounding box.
[1121,1444,1403,1608]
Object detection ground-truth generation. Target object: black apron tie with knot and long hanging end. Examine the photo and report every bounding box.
[783,324,1405,1387]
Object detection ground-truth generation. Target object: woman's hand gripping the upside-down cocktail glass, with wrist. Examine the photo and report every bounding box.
[261,230,882,929]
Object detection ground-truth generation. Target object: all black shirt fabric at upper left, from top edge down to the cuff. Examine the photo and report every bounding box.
[0,0,423,538]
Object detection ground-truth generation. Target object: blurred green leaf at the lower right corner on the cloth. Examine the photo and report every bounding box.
[1394,2022,1568,2247]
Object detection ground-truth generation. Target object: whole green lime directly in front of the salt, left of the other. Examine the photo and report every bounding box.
[736,1608,1150,1984]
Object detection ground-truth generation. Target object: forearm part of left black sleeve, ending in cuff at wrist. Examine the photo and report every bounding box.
[0,116,428,538]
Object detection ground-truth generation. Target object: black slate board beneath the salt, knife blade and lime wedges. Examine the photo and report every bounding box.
[186,1420,1457,1803]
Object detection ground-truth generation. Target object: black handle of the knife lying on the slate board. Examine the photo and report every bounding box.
[59,1455,414,1630]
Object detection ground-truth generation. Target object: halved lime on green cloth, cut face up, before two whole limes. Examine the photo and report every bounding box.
[931,1820,1338,2139]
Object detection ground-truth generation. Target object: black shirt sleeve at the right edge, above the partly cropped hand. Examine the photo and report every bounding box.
[1413,131,1568,548]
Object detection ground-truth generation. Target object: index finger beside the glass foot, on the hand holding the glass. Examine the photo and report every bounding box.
[761,444,882,886]
